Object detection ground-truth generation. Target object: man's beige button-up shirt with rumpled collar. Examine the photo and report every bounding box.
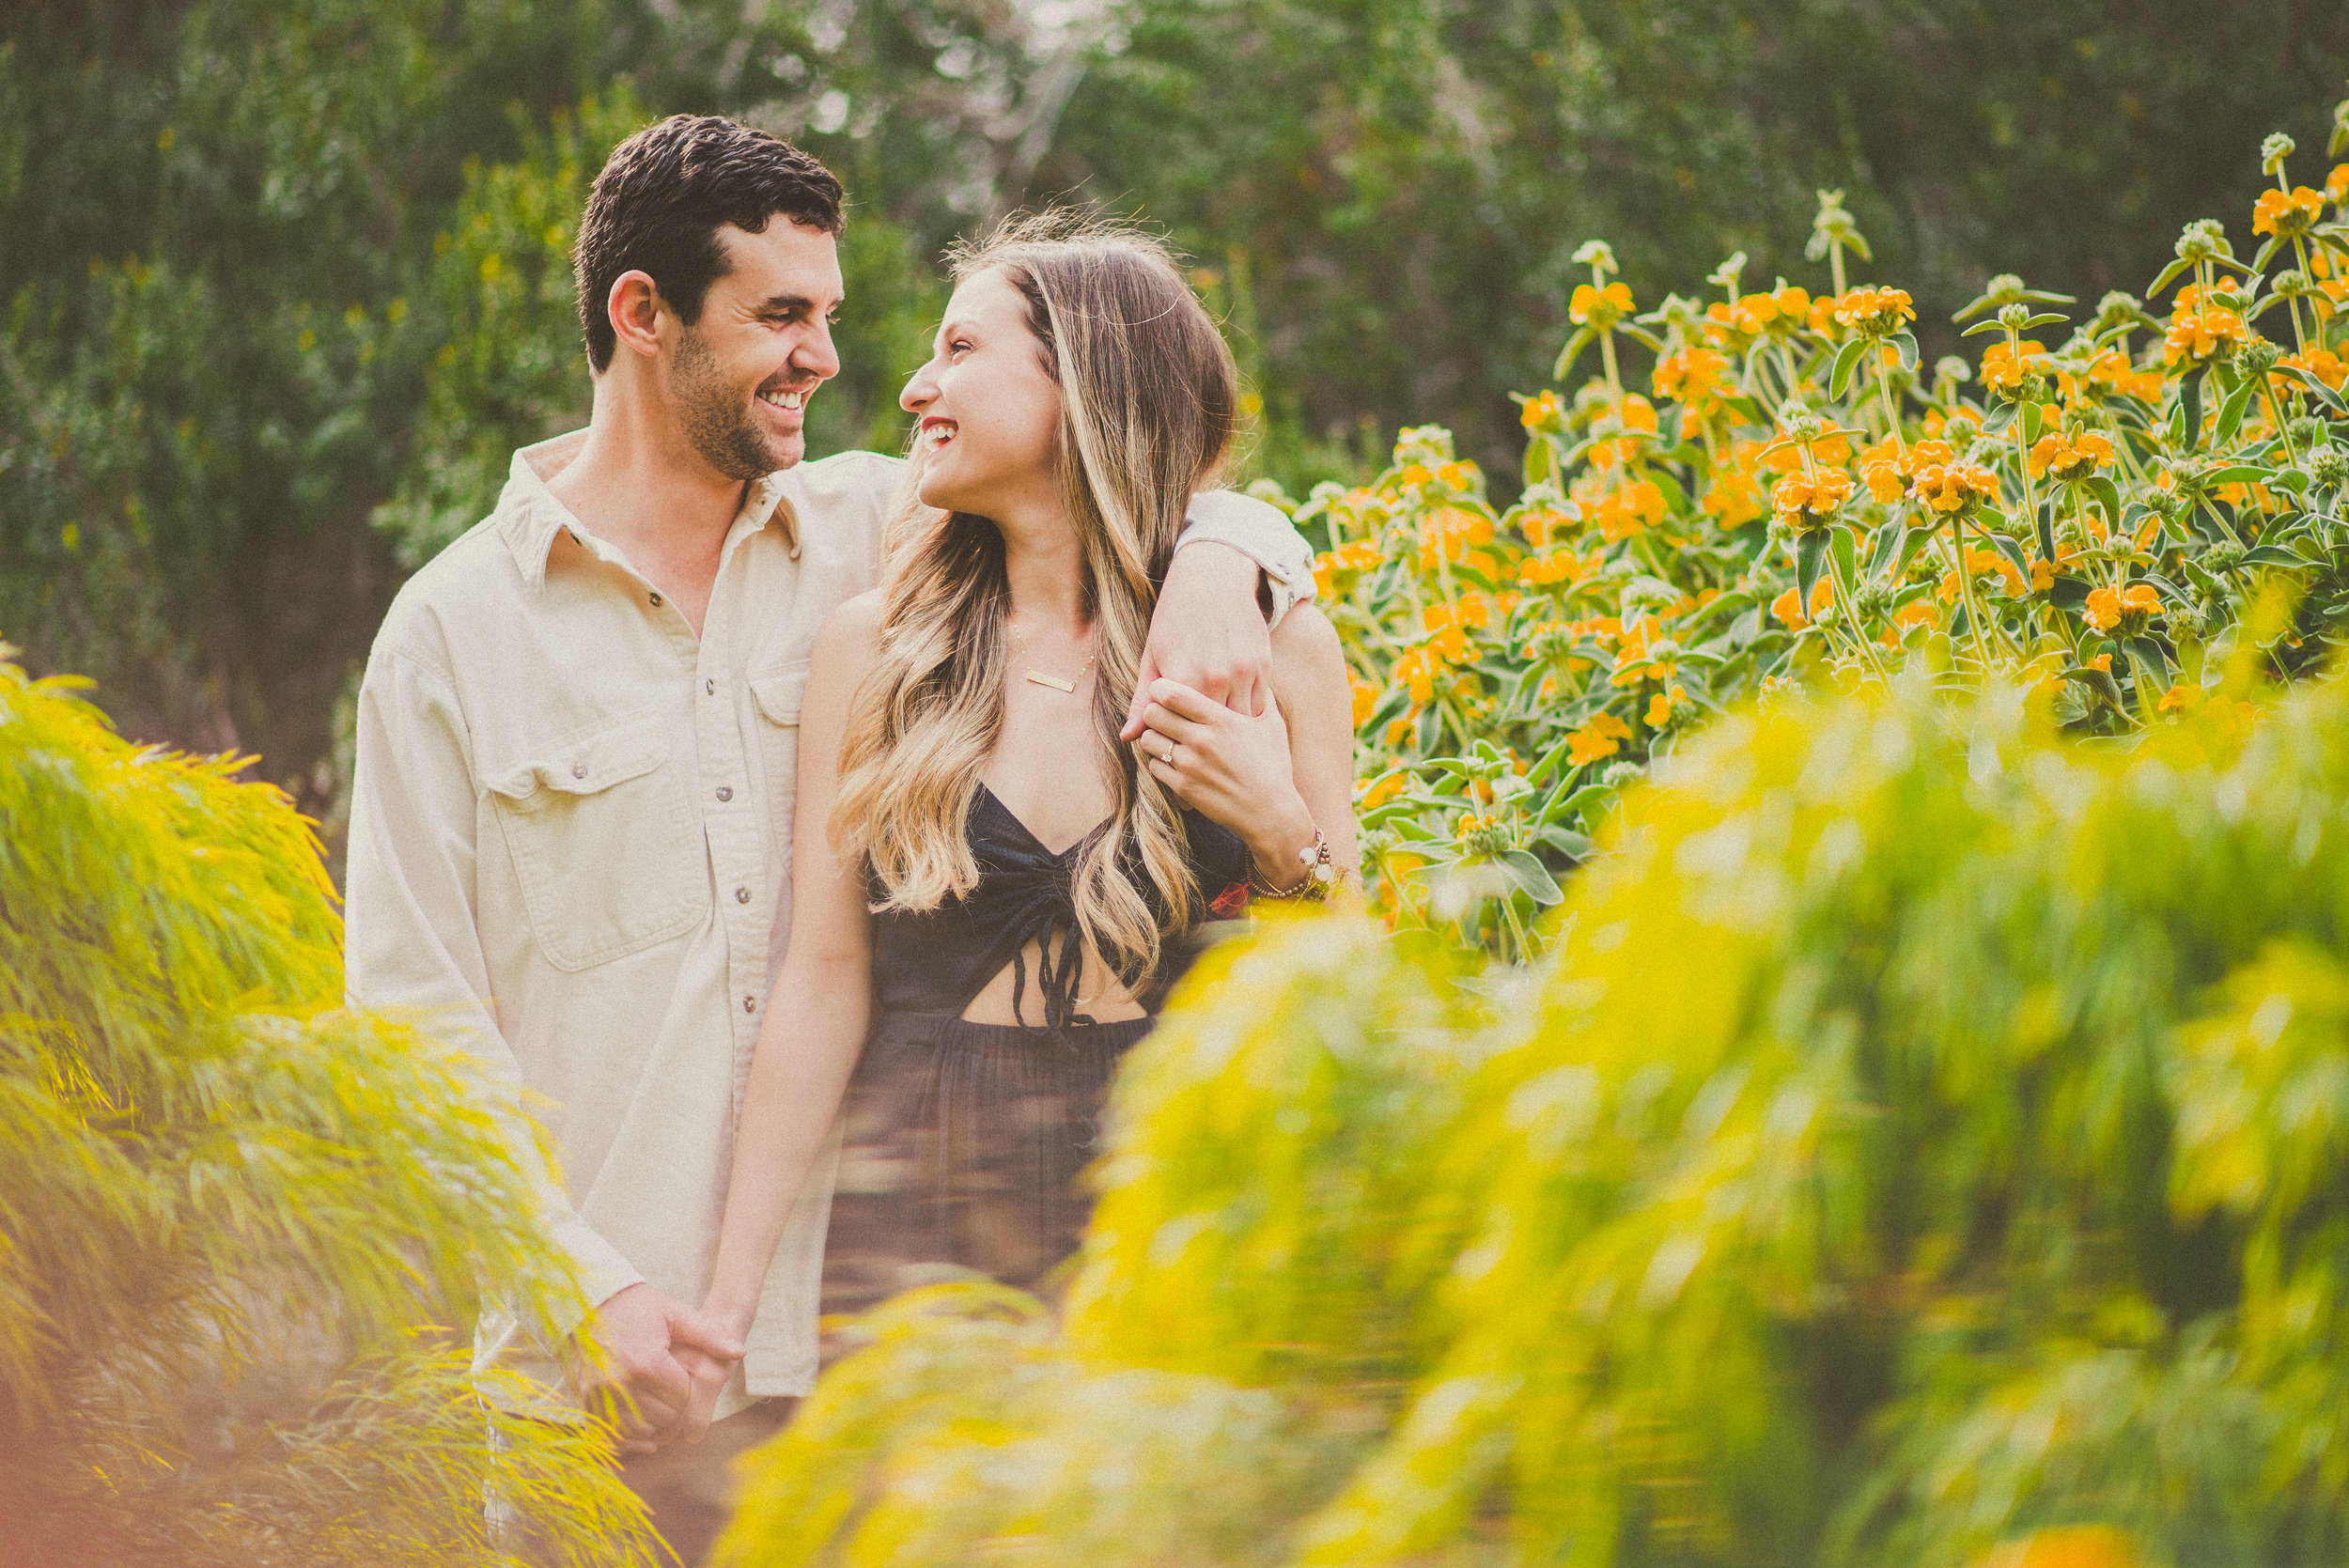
[348,432,1314,1416]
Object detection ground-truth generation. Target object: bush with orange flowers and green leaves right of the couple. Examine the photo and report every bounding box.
[1276,107,2349,957]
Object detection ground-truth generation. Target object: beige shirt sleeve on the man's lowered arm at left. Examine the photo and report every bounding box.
[343,648,644,1333]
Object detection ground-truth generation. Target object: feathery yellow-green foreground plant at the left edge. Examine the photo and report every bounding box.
[0,645,648,1568]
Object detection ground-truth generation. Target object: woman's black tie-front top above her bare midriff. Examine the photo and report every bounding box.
[867,784,1248,1028]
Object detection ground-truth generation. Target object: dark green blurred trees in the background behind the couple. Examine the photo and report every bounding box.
[0,0,2349,831]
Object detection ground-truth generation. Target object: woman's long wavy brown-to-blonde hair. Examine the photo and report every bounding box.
[830,211,1238,984]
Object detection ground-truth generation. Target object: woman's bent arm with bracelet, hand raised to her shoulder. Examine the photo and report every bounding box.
[1140,606,1362,887]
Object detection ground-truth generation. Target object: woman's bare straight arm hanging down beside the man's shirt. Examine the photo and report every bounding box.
[703,594,881,1336]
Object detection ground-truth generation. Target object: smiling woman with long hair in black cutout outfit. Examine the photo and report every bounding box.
[708,205,1358,1333]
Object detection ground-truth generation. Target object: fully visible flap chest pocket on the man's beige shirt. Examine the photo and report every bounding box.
[489,716,709,971]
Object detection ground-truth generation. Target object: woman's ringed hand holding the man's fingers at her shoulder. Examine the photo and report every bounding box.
[1135,676,1314,887]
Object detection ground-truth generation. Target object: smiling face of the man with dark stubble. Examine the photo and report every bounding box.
[667,213,841,479]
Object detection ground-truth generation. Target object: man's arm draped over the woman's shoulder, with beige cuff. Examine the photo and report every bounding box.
[1123,490,1314,739]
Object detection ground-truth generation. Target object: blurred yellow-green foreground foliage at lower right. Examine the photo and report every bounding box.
[728,678,2349,1568]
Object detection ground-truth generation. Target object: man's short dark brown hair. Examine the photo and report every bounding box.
[573,115,841,371]
